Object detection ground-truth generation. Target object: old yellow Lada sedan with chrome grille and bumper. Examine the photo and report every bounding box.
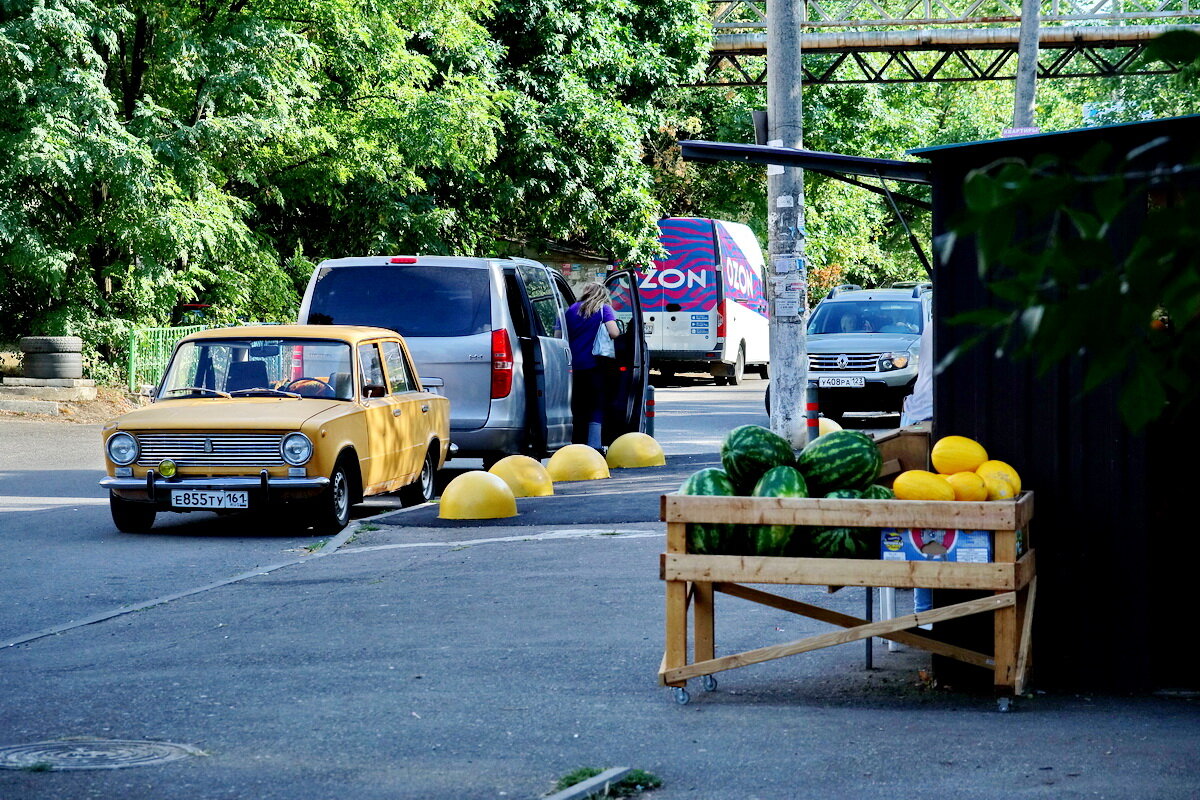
[100,325,452,534]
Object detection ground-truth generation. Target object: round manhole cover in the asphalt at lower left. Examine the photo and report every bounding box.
[0,739,204,770]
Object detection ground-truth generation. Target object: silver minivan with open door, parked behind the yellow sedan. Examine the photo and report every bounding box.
[299,255,647,464]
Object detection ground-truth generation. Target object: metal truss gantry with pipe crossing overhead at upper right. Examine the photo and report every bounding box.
[696,0,1200,86]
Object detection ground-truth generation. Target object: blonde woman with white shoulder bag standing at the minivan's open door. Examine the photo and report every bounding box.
[566,283,620,450]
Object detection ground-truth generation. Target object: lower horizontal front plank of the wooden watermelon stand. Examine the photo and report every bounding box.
[662,553,1016,591]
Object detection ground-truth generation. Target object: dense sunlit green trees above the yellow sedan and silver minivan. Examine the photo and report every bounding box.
[0,0,708,359]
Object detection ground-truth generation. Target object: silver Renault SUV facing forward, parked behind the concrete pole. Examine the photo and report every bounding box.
[808,283,934,421]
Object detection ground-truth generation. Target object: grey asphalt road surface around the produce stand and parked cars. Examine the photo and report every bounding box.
[0,381,1200,800]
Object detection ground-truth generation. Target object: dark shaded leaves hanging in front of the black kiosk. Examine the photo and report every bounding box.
[946,32,1200,431]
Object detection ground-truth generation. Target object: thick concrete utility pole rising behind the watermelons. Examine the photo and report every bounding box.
[763,0,809,447]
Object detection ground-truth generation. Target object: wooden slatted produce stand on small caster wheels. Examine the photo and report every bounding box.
[659,492,1037,702]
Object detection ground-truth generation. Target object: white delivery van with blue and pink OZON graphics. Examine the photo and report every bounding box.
[637,217,770,385]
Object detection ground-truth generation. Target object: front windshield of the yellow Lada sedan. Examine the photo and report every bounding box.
[158,338,354,399]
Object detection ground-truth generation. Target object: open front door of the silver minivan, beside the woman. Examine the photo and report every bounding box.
[602,270,650,445]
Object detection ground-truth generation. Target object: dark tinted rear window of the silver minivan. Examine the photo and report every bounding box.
[307,265,492,336]
